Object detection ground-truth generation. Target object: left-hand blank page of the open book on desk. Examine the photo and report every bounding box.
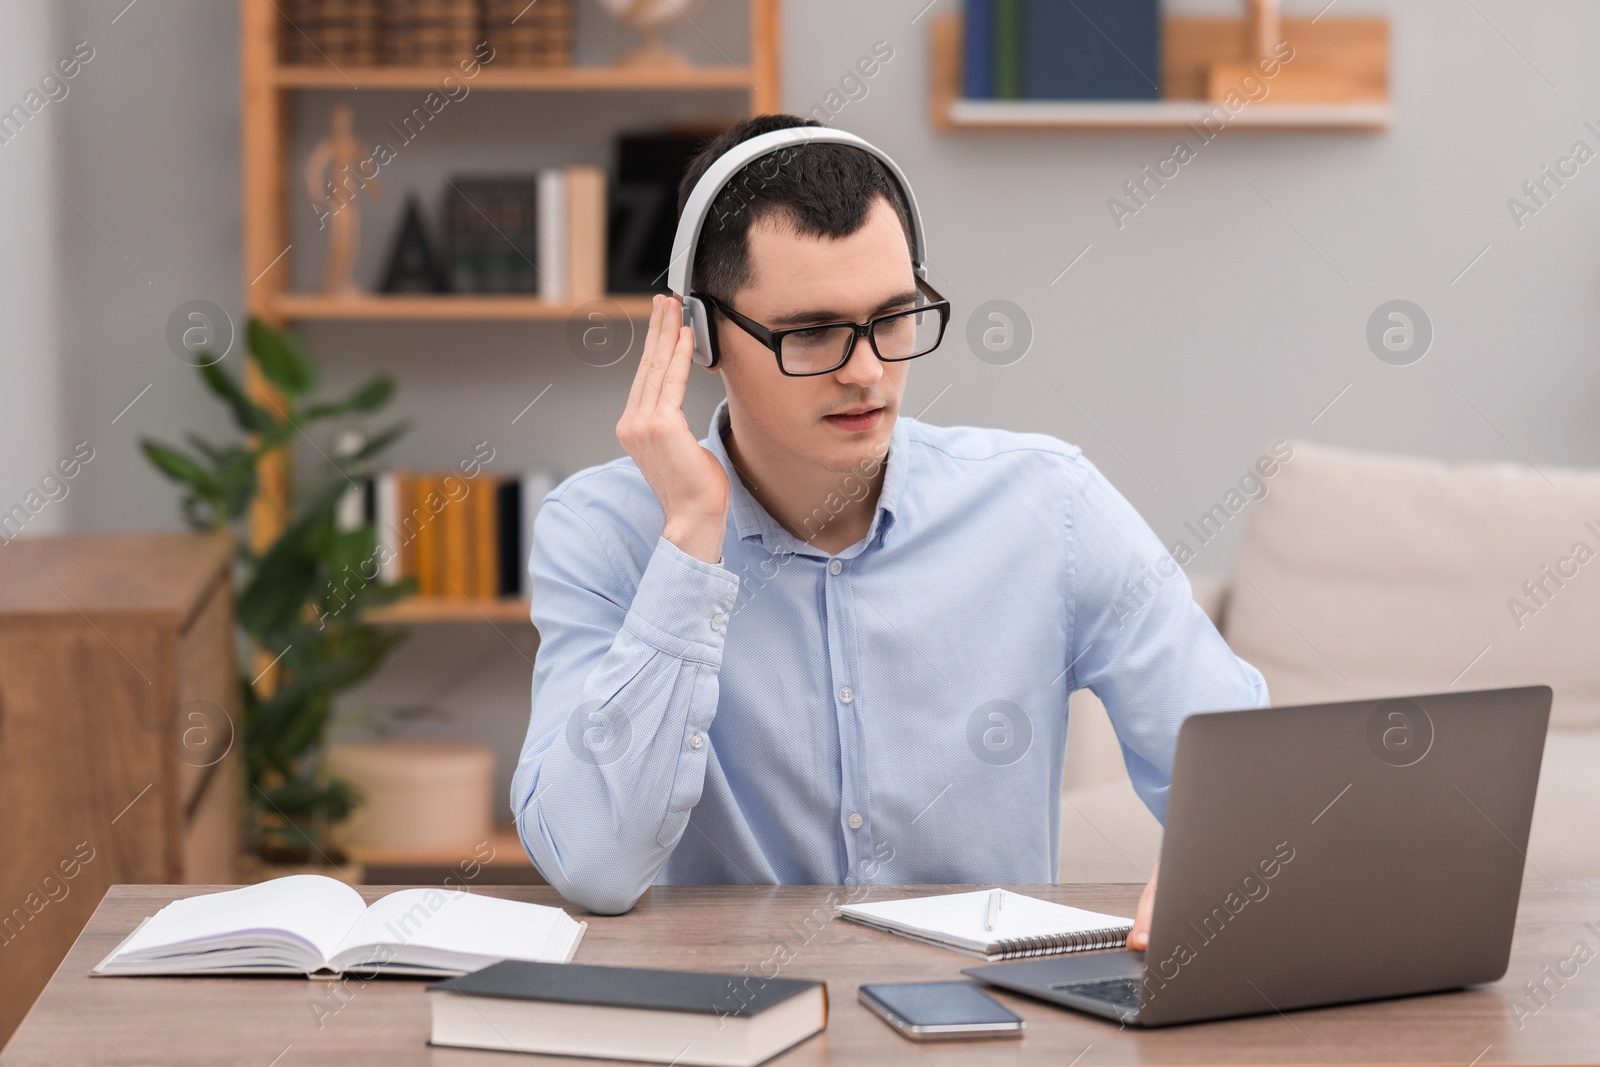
[120,875,366,960]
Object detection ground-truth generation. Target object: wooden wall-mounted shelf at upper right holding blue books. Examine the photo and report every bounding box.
[930,13,1394,131]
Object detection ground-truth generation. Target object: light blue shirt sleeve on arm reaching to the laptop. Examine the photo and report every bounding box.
[1066,454,1269,822]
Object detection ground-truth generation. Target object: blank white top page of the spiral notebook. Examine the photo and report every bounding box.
[837,889,1133,949]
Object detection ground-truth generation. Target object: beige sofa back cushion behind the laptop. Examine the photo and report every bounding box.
[1224,442,1600,729]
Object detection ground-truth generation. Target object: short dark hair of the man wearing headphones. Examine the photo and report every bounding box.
[678,115,915,308]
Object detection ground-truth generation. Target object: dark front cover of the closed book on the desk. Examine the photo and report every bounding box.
[427,960,826,1016]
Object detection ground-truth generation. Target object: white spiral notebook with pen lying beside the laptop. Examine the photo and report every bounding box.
[834,889,1133,961]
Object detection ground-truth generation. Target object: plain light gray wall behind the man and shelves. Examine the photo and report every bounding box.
[15,0,1600,799]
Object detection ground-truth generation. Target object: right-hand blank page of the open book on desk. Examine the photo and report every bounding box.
[330,888,576,961]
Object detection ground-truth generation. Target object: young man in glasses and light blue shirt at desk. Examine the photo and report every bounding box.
[510,115,1267,913]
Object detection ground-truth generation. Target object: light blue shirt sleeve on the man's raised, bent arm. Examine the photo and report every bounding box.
[510,494,739,913]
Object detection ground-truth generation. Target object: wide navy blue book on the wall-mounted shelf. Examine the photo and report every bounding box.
[1022,0,1162,99]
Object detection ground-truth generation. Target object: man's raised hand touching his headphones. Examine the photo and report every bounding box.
[616,287,731,563]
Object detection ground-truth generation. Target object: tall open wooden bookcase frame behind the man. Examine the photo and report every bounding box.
[240,0,779,624]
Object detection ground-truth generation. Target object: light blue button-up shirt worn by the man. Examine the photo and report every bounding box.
[510,400,1267,913]
